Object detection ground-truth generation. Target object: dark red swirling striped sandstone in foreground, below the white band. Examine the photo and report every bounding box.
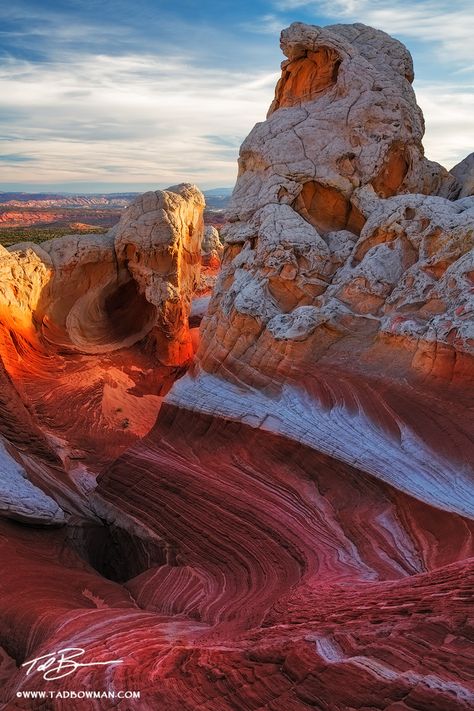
[1,406,474,711]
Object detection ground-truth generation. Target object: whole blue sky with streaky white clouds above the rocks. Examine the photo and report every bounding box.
[0,0,474,192]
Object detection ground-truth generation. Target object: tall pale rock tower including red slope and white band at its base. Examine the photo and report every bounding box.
[170,23,474,514]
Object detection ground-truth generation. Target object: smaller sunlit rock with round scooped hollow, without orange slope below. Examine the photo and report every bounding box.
[0,184,204,365]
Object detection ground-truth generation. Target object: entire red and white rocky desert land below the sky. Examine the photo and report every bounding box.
[0,22,474,711]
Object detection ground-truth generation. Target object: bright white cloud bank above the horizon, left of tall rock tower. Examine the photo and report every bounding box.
[0,55,277,187]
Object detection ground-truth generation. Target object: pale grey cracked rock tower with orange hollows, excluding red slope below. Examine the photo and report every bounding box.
[196,23,474,378]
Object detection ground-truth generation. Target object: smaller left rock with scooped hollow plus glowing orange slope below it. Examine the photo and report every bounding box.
[0,184,204,525]
